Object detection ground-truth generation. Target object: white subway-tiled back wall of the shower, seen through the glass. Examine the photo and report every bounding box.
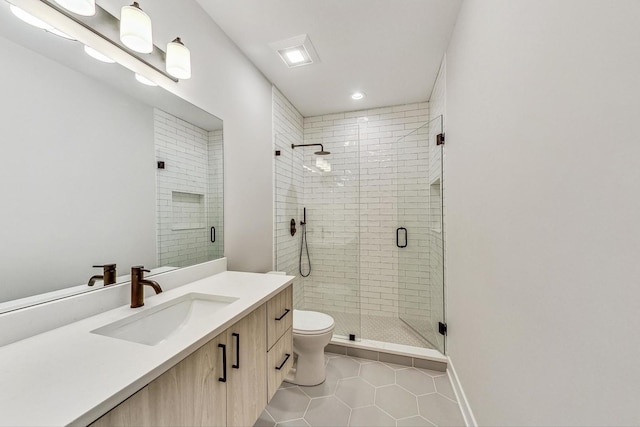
[304,103,428,324]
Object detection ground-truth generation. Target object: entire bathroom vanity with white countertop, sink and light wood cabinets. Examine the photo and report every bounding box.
[0,271,293,426]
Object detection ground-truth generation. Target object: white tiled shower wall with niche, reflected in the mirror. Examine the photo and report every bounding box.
[154,109,223,267]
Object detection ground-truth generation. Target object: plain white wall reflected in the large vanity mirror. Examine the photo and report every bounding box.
[0,37,156,302]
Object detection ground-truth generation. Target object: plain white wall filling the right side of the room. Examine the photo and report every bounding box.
[445,0,640,425]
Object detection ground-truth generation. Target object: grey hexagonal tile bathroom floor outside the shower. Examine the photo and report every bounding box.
[255,353,464,427]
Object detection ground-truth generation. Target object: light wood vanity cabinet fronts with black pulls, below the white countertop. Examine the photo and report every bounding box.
[91,286,293,427]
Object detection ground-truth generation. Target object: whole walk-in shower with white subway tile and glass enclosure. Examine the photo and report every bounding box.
[275,108,445,352]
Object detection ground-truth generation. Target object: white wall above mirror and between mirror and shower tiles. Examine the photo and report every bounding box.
[125,0,273,272]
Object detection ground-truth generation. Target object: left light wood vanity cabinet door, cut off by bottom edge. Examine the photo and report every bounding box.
[92,333,229,427]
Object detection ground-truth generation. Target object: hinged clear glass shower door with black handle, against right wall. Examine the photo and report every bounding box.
[395,118,444,352]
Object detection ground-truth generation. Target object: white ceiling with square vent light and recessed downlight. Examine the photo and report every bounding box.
[196,0,462,117]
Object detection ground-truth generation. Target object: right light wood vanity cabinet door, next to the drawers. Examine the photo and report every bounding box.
[227,304,267,427]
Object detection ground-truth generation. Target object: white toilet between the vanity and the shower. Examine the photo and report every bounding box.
[285,309,335,386]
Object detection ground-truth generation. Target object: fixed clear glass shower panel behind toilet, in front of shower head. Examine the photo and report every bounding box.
[274,129,361,339]
